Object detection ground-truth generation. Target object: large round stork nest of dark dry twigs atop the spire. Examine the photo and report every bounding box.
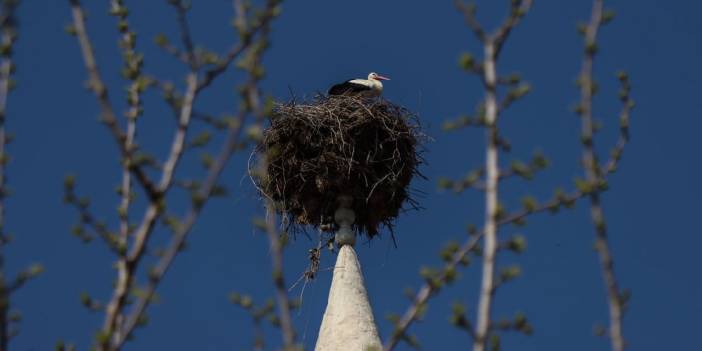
[257,96,424,238]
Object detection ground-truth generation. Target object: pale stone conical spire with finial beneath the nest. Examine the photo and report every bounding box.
[314,198,382,351]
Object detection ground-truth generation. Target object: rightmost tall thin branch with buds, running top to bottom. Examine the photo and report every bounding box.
[579,0,628,351]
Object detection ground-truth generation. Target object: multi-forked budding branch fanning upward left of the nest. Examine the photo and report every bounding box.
[70,0,278,351]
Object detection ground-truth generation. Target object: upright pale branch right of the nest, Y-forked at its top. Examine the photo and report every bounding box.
[385,4,532,351]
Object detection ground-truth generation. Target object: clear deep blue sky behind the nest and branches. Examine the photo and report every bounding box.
[6,0,702,351]
